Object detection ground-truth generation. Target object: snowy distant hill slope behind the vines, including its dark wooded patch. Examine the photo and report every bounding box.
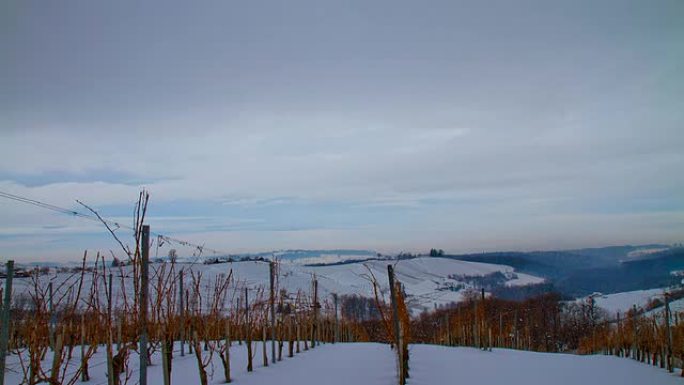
[0,257,544,314]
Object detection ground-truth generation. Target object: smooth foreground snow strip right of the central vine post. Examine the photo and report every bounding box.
[408,345,681,385]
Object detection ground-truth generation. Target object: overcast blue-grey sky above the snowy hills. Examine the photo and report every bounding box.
[0,0,684,260]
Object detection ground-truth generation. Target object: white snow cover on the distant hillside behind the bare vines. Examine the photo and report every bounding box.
[0,257,544,312]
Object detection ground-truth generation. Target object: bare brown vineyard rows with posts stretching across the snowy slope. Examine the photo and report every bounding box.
[0,195,684,385]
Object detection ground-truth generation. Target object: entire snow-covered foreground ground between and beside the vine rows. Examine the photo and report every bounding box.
[6,343,682,385]
